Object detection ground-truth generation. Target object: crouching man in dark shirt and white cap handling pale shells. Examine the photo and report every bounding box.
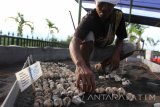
[69,0,135,92]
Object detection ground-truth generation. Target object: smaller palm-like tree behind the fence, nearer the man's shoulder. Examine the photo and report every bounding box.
[46,19,59,39]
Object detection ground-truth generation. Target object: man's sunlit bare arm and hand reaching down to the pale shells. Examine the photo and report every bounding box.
[69,36,95,92]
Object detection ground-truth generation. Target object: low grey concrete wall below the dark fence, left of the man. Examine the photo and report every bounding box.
[0,46,70,65]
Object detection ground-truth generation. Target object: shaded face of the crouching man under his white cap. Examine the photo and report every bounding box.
[96,2,115,20]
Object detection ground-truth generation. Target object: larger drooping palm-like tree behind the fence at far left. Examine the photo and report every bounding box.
[9,13,34,37]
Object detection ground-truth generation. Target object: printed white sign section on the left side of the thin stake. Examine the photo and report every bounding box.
[16,67,32,92]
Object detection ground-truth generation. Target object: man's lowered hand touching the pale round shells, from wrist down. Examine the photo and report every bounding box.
[76,66,95,92]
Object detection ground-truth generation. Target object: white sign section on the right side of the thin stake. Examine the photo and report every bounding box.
[29,61,42,81]
